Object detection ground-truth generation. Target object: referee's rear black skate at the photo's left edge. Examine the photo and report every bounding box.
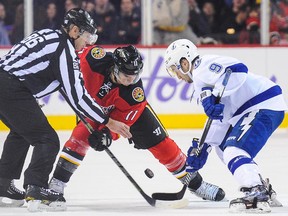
[0,180,25,207]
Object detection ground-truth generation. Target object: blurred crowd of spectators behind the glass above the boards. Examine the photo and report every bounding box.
[0,0,288,46]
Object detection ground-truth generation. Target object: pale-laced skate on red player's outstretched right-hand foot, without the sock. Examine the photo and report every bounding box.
[189,181,225,201]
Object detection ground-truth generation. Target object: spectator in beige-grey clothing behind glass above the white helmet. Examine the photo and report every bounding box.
[152,0,200,45]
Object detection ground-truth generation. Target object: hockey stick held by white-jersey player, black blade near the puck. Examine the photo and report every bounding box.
[152,68,232,200]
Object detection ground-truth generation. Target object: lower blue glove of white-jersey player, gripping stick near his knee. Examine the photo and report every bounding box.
[186,138,211,173]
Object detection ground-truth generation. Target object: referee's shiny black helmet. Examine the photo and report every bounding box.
[63,8,97,34]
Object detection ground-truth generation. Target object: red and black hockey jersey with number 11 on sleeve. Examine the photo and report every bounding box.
[79,46,147,126]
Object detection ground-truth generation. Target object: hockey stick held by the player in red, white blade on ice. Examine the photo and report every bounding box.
[59,89,188,208]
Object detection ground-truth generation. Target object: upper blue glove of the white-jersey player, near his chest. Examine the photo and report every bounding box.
[200,87,224,121]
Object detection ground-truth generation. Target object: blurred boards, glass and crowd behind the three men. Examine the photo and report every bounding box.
[0,0,288,130]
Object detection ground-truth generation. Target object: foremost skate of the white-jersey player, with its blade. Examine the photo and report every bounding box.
[229,185,271,213]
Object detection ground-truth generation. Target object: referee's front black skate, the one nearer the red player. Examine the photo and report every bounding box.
[25,185,66,212]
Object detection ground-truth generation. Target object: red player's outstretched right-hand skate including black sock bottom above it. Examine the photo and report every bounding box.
[180,172,225,201]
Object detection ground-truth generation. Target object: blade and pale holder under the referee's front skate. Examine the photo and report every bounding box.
[27,200,67,212]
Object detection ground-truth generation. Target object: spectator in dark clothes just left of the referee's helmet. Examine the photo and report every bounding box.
[42,2,60,29]
